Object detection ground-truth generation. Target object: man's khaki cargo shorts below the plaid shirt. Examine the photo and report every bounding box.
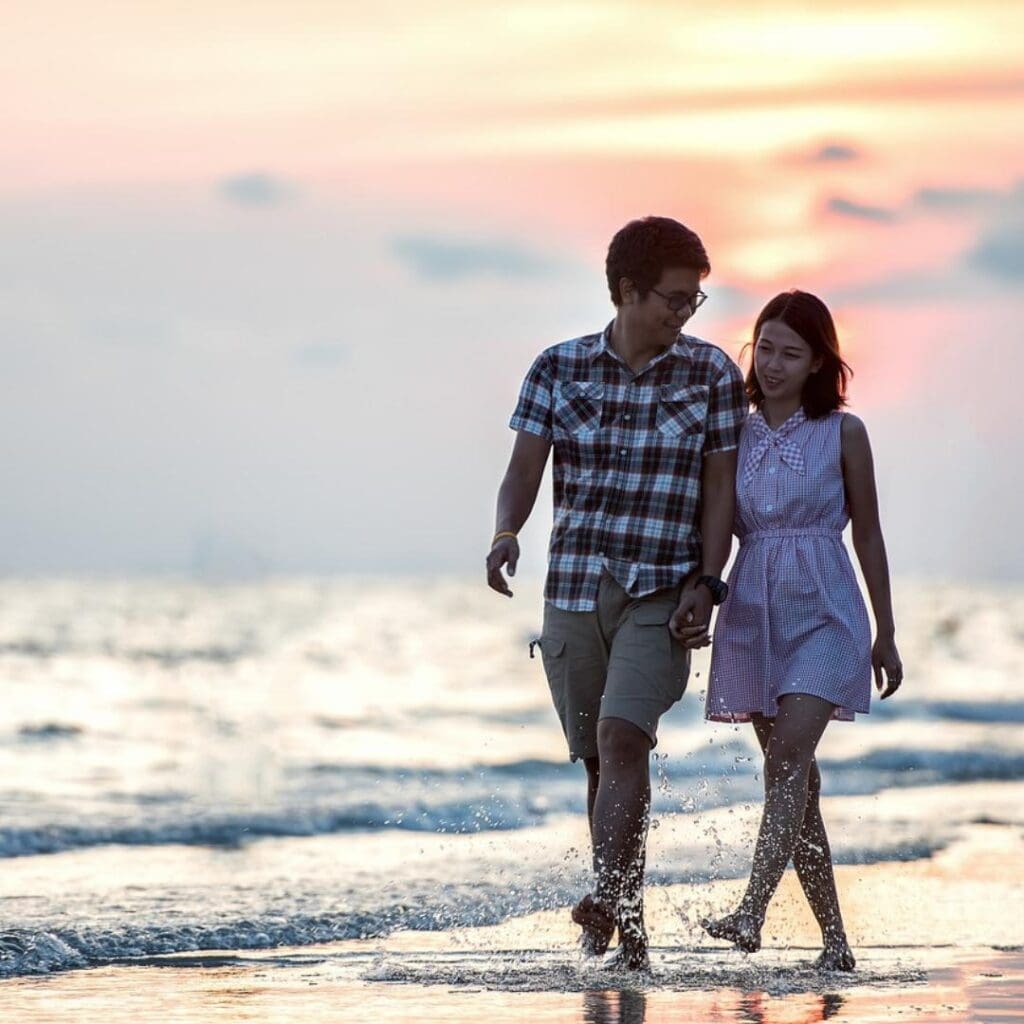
[540,572,690,761]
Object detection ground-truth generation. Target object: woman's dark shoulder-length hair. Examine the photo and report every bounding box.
[743,289,853,420]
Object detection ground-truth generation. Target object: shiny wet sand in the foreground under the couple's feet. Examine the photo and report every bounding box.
[0,823,1024,1024]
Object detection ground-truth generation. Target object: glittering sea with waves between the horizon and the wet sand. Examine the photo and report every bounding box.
[0,577,1024,977]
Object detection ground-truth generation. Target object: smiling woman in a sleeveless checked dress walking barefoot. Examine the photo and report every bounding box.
[702,291,903,971]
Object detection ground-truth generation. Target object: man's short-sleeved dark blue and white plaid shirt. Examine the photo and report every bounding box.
[509,325,748,611]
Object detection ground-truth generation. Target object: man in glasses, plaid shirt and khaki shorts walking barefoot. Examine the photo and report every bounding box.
[486,217,746,970]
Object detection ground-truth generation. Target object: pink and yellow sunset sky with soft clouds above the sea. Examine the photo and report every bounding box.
[0,0,1024,580]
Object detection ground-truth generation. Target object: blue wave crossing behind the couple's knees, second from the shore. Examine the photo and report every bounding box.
[0,744,1024,858]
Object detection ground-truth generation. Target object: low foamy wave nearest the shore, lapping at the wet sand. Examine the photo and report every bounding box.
[0,829,943,978]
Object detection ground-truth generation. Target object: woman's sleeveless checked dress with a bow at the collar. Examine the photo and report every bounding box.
[705,409,871,722]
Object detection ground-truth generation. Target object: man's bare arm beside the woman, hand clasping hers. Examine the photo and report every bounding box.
[669,449,736,647]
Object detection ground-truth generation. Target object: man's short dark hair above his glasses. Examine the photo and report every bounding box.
[604,217,711,306]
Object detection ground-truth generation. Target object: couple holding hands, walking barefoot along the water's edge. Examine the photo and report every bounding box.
[486,217,902,971]
